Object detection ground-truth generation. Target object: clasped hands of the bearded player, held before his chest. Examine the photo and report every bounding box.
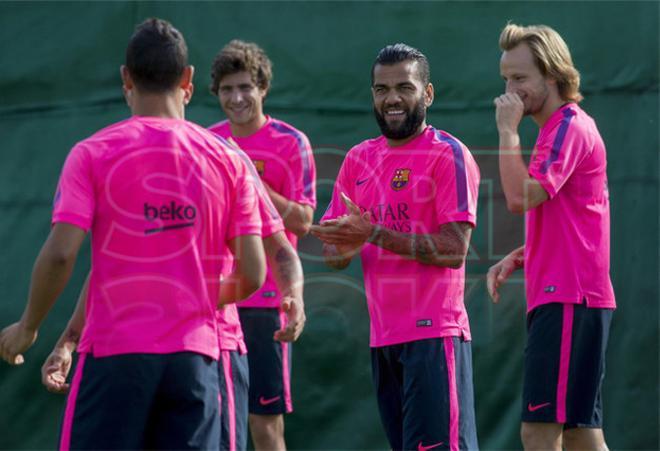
[310,193,374,247]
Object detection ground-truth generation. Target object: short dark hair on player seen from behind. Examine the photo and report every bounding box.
[126,18,188,93]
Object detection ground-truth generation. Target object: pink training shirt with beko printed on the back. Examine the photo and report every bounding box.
[53,116,262,359]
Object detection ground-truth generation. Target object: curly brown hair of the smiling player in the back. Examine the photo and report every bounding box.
[210,39,273,96]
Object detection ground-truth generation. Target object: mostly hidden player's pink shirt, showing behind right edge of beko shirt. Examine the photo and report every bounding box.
[210,137,284,354]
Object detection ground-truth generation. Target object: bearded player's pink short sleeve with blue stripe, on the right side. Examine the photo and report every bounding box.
[434,135,480,227]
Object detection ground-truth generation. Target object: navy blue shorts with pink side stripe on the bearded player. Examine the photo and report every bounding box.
[371,337,479,451]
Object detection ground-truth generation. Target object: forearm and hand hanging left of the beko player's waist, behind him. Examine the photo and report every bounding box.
[41,274,89,393]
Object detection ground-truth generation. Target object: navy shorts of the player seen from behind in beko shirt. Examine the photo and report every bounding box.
[59,352,220,450]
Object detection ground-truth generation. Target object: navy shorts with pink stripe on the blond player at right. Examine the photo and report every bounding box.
[522,303,613,429]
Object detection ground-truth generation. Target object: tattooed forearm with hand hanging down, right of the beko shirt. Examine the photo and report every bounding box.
[264,232,305,341]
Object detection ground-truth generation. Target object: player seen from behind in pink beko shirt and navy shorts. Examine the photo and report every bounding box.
[0,19,266,450]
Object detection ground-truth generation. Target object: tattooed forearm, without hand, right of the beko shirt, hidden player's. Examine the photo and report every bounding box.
[264,233,304,299]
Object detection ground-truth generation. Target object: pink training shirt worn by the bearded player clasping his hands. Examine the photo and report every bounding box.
[322,126,480,347]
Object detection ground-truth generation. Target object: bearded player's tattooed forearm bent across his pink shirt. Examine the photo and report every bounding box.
[369,223,471,269]
